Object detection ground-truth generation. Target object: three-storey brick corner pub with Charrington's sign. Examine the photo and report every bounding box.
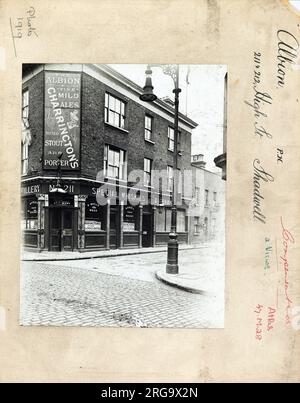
[21,64,197,252]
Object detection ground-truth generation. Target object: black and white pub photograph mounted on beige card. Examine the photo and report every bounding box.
[20,63,227,329]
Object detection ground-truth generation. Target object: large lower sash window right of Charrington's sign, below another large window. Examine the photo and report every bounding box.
[104,145,126,180]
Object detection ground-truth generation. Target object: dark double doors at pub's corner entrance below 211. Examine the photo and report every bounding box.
[50,208,74,251]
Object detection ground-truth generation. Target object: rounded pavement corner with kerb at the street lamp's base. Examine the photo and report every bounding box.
[155,269,210,295]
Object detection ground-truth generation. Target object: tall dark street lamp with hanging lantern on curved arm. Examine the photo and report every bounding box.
[140,64,181,274]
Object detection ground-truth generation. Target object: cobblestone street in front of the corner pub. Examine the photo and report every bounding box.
[20,250,224,328]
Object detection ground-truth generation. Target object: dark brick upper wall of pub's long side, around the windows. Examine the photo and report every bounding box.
[81,74,191,178]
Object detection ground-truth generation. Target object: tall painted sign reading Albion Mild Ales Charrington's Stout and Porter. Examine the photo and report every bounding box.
[44,72,81,171]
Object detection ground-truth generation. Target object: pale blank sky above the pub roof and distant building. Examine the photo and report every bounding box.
[110,64,227,172]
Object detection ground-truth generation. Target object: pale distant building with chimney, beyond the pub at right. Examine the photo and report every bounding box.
[190,154,225,244]
